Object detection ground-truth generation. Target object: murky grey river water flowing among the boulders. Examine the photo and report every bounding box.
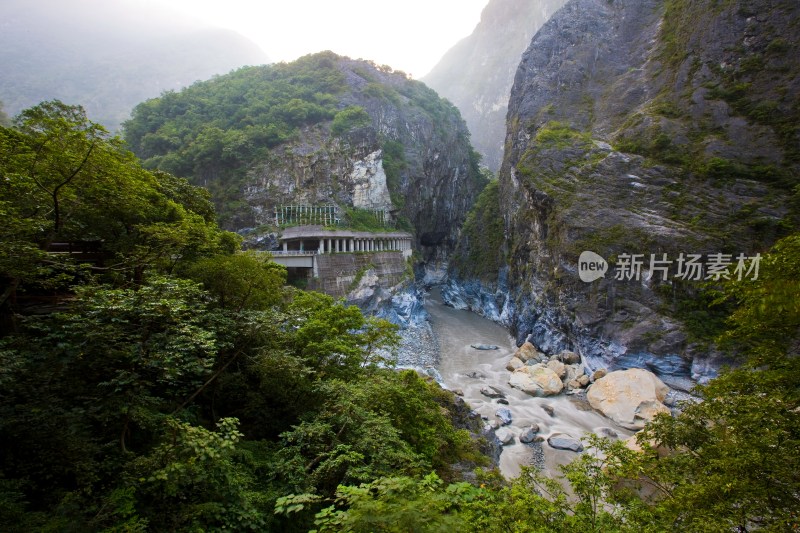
[425,288,631,477]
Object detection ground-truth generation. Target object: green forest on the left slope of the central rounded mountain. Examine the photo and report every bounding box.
[124,53,346,227]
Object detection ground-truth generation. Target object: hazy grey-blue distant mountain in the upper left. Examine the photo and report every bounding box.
[0,0,268,130]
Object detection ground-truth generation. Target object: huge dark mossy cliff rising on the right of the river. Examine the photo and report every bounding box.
[452,0,800,386]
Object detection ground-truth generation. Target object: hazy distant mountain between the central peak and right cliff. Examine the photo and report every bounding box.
[422,0,566,172]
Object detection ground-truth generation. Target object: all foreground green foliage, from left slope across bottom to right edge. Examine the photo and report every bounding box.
[0,102,800,533]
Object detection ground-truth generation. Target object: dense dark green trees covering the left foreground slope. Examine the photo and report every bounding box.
[0,102,484,532]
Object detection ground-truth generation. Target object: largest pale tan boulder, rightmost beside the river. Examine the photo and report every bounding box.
[586,368,670,430]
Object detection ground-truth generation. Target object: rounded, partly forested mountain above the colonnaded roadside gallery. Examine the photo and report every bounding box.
[125,52,485,262]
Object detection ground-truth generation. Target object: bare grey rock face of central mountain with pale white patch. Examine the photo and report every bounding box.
[245,56,485,262]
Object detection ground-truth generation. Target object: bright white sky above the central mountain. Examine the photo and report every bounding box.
[131,0,489,79]
